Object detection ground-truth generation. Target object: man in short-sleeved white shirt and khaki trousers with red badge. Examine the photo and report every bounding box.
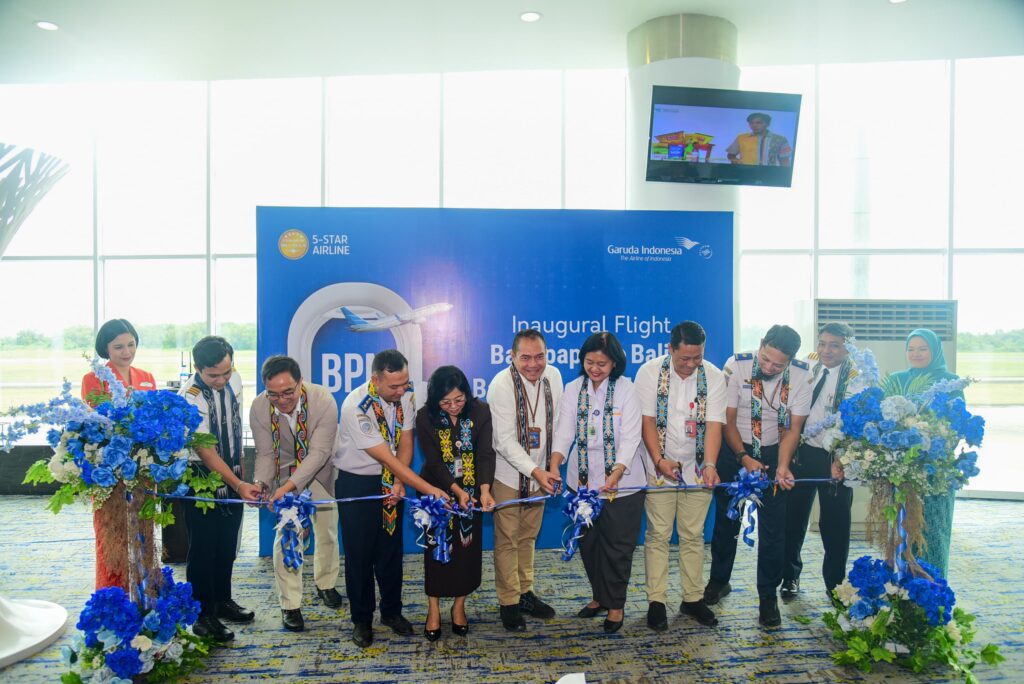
[636,320,726,632]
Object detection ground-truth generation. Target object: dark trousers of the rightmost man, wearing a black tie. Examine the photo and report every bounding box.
[782,444,853,591]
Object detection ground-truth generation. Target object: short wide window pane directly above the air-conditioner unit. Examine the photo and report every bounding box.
[818,254,946,299]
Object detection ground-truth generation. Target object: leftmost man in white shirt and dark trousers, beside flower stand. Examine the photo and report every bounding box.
[178,335,260,642]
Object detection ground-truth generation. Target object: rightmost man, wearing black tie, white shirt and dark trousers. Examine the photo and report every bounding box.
[779,323,857,599]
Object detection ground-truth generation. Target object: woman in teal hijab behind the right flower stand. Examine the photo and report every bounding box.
[890,328,964,576]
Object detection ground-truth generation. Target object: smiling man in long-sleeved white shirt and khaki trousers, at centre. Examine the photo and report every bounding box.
[487,330,562,632]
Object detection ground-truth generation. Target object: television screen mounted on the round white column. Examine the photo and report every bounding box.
[647,86,801,187]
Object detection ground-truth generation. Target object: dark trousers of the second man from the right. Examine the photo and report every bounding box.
[710,444,787,598]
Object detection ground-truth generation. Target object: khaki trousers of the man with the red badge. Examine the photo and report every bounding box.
[643,477,711,603]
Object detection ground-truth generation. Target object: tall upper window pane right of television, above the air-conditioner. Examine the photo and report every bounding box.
[818,61,949,249]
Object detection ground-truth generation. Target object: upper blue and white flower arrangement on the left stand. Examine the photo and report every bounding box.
[0,358,221,524]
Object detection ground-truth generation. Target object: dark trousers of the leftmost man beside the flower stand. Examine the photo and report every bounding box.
[184,497,244,614]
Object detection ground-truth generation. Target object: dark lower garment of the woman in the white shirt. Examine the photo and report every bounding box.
[580,491,646,610]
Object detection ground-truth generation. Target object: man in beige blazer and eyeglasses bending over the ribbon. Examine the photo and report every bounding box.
[249,356,342,632]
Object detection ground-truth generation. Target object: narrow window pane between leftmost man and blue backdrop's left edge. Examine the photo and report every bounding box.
[213,254,259,405]
